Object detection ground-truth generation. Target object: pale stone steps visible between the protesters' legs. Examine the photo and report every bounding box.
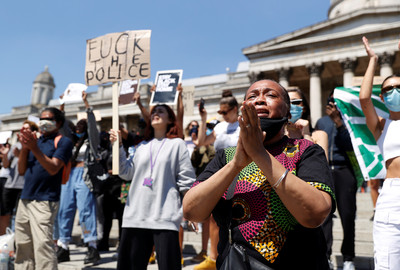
[59,193,374,270]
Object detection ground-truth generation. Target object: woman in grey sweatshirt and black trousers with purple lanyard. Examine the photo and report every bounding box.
[110,105,195,270]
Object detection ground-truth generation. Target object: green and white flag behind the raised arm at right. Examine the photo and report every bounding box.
[333,85,389,181]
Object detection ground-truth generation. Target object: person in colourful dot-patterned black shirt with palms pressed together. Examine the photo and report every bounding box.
[183,80,334,269]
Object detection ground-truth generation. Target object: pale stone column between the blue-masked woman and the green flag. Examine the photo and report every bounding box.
[307,64,323,126]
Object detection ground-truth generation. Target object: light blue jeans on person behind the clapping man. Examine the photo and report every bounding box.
[58,167,97,243]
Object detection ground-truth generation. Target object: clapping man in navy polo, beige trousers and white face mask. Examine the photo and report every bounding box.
[15,107,72,269]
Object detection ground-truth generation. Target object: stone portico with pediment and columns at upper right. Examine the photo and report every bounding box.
[243,0,400,123]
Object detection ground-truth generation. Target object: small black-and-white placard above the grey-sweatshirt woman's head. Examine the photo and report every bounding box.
[150,69,183,106]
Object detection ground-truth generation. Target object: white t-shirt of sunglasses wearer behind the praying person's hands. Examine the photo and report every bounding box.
[214,121,240,151]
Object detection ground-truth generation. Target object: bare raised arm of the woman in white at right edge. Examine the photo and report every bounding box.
[359,37,382,140]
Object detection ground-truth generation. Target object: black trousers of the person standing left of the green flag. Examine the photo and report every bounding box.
[322,166,357,261]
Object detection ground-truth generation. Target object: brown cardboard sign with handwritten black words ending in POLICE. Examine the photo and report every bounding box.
[85,30,151,85]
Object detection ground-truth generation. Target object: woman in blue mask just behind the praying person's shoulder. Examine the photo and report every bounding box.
[286,88,328,160]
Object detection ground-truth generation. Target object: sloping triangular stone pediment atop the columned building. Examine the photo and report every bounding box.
[242,5,400,61]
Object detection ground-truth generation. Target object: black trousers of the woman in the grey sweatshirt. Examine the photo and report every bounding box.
[117,228,182,270]
